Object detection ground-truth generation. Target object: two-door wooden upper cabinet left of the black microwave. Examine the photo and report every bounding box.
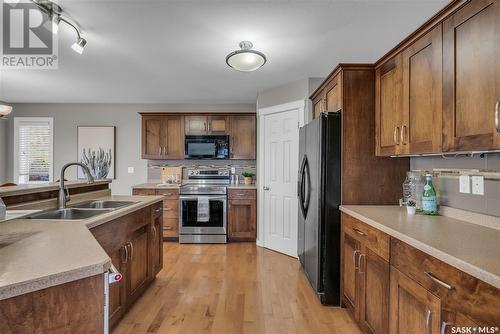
[142,115,184,159]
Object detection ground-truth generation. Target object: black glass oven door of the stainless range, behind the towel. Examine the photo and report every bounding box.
[179,195,227,234]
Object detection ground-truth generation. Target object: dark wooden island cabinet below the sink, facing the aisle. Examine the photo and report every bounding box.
[90,202,163,329]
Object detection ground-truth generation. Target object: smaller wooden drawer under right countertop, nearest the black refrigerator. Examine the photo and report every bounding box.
[342,213,390,261]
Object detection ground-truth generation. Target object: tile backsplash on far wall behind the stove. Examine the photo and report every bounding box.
[148,160,257,182]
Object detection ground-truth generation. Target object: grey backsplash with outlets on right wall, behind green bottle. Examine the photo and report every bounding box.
[411,153,500,217]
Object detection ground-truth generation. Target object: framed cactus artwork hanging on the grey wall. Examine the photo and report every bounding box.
[77,126,116,180]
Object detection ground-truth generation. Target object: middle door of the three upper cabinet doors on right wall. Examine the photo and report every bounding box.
[400,25,443,154]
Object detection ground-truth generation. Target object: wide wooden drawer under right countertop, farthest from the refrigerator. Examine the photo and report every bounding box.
[391,238,500,326]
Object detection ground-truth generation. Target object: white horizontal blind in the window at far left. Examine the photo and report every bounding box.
[18,121,52,184]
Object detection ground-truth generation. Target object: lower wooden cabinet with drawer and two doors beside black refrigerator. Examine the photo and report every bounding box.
[342,214,390,333]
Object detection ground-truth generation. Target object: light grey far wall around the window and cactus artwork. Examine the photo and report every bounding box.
[7,103,255,194]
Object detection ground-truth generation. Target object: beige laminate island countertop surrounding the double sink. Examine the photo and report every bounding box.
[0,196,162,300]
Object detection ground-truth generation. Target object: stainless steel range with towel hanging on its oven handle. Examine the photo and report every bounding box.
[179,168,230,243]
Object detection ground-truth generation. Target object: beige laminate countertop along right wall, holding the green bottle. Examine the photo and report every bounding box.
[340,205,500,289]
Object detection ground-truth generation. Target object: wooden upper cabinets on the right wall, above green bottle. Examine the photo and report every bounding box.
[375,0,500,156]
